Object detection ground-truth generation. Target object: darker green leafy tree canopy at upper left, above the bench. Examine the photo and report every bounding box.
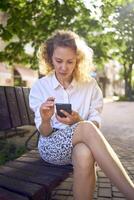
[0,0,86,68]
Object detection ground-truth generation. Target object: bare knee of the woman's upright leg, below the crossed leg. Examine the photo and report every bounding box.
[72,143,95,172]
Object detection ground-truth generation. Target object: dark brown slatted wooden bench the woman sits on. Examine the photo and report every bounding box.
[0,86,72,200]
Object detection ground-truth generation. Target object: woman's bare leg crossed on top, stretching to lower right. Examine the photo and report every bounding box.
[73,122,134,200]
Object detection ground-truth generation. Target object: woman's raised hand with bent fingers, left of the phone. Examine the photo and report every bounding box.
[40,97,55,122]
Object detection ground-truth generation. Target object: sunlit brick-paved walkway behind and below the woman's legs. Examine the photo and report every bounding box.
[52,102,134,200]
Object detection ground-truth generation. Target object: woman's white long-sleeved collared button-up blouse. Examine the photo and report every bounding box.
[29,74,103,129]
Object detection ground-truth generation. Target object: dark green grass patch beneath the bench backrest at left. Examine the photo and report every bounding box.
[0,140,27,165]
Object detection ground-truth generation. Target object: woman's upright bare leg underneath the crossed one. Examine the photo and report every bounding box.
[72,143,95,200]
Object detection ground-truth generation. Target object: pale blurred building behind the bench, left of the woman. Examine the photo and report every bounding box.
[0,11,38,87]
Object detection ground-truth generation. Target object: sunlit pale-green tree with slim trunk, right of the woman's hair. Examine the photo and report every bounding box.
[91,0,134,99]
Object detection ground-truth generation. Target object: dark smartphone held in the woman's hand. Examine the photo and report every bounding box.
[55,103,72,117]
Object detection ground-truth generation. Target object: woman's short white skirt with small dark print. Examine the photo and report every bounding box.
[38,123,78,165]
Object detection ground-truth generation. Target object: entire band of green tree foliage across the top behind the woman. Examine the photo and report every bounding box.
[0,0,134,98]
